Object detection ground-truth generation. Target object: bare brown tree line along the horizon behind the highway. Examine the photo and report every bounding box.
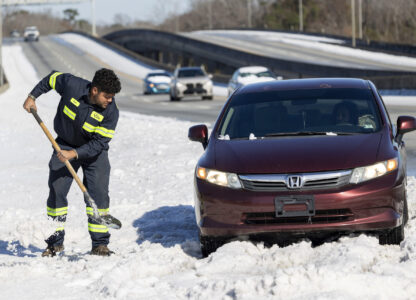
[3,0,416,44]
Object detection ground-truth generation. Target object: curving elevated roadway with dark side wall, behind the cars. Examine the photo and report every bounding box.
[103,29,416,89]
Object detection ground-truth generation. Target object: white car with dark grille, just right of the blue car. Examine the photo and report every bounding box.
[170,67,213,101]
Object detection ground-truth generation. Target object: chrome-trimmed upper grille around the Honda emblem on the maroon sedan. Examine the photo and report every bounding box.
[239,170,351,192]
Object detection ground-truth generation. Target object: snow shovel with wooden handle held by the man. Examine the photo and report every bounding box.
[30,108,121,229]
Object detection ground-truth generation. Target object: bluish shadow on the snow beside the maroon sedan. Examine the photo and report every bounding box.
[133,205,201,257]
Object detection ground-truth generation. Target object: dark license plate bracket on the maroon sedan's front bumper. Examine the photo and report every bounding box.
[274,195,315,218]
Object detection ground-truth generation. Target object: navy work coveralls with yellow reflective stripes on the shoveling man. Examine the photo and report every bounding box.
[31,71,119,247]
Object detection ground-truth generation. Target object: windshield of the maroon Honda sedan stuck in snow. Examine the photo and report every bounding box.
[217,88,381,140]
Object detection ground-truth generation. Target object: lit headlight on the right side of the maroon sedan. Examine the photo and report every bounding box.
[350,158,398,183]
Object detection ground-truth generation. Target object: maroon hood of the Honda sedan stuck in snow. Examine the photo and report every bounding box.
[214,132,383,174]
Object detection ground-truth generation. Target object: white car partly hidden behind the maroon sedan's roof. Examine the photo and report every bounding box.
[228,66,283,95]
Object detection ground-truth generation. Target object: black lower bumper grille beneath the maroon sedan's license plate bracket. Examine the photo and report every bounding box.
[243,209,354,225]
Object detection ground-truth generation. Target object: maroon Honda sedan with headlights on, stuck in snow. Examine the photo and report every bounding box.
[189,78,416,256]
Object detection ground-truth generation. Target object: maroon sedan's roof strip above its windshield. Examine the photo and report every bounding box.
[237,78,370,94]
